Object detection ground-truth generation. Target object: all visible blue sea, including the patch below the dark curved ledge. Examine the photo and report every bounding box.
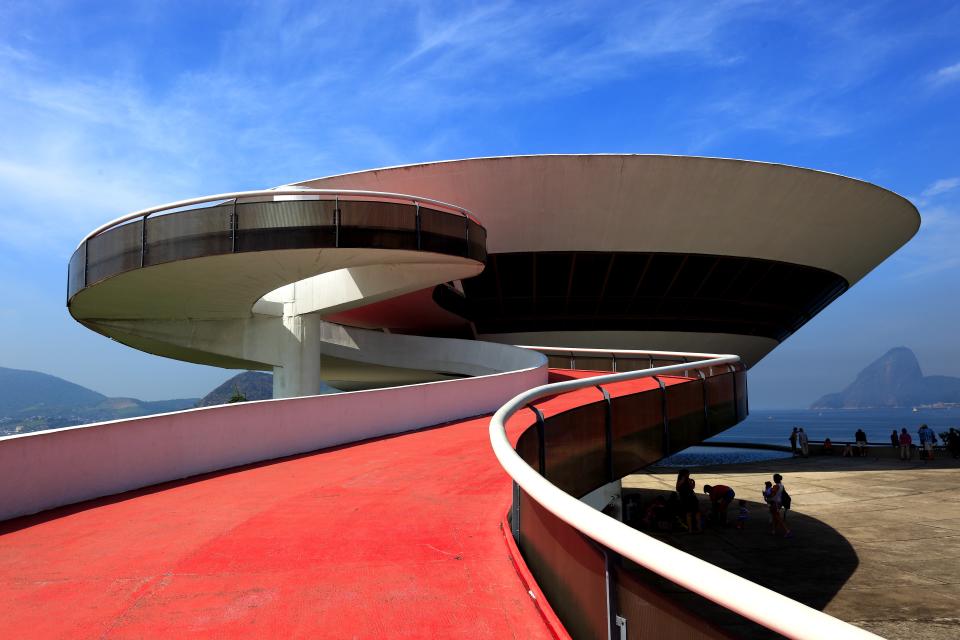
[656,408,960,467]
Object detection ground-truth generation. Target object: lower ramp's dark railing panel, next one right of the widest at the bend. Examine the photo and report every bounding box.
[610,390,664,478]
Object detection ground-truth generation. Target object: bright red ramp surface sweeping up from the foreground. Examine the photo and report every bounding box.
[0,372,668,638]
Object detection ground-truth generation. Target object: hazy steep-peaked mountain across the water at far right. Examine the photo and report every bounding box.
[810,347,960,409]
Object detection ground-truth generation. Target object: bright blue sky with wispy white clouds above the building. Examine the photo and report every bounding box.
[0,0,960,408]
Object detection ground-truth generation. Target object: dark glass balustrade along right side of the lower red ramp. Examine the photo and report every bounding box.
[510,364,748,640]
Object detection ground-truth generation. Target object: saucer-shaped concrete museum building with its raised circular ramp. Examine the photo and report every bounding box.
[63,155,919,397]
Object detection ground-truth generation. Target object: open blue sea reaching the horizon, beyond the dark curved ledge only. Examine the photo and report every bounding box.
[710,409,960,446]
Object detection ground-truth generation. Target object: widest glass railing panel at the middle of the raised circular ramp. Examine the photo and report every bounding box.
[236,200,337,251]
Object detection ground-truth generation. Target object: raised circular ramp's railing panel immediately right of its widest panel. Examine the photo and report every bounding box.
[339,200,417,250]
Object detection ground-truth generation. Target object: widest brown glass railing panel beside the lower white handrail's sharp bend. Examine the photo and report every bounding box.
[544,401,609,497]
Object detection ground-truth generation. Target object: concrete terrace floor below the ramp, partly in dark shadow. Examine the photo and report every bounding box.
[623,457,960,640]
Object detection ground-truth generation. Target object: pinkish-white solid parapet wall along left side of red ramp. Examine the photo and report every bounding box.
[0,352,547,520]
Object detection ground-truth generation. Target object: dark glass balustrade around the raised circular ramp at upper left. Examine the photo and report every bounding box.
[67,199,487,302]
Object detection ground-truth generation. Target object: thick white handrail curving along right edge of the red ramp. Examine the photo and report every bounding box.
[490,352,879,640]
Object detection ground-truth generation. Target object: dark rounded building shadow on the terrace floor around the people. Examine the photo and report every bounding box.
[623,489,859,639]
